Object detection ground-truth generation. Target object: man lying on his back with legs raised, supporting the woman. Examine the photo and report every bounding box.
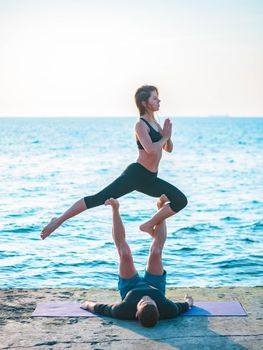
[81,195,193,327]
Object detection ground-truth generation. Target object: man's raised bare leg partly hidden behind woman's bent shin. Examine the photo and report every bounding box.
[146,195,168,275]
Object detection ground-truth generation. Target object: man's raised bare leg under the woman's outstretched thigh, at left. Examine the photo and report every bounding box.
[105,198,137,278]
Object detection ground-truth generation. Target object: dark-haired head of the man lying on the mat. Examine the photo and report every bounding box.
[136,295,159,327]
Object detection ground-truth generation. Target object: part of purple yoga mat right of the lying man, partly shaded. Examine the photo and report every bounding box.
[182,301,247,316]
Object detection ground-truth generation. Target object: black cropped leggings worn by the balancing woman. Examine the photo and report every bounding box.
[84,163,187,213]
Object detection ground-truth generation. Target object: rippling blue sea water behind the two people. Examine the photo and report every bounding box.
[0,117,263,288]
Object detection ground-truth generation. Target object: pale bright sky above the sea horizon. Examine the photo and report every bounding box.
[0,0,263,117]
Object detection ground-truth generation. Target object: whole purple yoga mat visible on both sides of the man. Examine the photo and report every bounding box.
[32,301,247,317]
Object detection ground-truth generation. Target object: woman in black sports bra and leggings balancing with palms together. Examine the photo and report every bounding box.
[41,85,187,239]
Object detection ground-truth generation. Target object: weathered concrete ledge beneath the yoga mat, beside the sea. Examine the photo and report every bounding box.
[0,287,263,350]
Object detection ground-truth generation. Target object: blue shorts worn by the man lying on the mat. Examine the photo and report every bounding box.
[118,270,166,300]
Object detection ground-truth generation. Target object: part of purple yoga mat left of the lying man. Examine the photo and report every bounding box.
[32,301,95,317]
